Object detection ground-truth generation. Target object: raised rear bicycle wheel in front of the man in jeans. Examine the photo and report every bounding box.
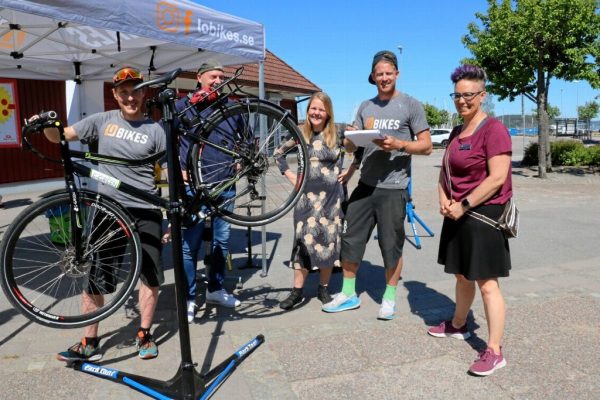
[188,99,308,226]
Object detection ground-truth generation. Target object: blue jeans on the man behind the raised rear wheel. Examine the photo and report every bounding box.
[182,190,235,301]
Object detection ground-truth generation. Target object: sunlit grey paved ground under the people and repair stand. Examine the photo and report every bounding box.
[0,138,600,400]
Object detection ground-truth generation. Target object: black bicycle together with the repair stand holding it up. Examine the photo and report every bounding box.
[0,69,307,399]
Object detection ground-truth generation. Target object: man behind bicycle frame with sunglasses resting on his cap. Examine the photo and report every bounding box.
[39,67,166,362]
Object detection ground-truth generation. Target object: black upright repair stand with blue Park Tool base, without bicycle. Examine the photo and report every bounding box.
[70,83,265,400]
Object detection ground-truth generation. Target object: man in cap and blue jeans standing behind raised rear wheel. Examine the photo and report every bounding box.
[170,60,241,322]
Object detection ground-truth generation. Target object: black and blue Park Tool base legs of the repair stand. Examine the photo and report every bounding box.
[67,335,265,400]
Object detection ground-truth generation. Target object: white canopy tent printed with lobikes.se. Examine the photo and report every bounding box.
[0,0,266,271]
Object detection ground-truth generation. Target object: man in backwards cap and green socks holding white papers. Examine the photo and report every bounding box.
[322,51,432,320]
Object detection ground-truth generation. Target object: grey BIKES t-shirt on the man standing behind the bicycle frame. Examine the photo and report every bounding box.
[72,110,166,208]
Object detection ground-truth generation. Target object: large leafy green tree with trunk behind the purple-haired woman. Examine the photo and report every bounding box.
[463,0,600,178]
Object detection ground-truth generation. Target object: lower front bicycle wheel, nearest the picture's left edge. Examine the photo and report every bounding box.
[0,191,141,328]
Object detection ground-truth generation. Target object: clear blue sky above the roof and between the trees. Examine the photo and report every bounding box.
[196,0,600,122]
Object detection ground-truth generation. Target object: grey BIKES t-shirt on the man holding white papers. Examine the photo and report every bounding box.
[354,93,429,189]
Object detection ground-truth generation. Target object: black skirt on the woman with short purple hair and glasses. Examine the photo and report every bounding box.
[438,204,511,280]
